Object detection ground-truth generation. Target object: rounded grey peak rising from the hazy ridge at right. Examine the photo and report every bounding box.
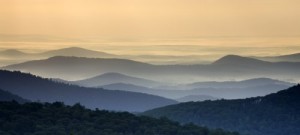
[212,55,267,65]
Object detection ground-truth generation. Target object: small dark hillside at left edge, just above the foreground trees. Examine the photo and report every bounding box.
[0,89,29,103]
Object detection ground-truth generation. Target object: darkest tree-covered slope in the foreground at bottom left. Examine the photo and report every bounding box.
[0,102,239,135]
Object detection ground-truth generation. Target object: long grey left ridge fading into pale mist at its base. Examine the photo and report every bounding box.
[4,56,157,80]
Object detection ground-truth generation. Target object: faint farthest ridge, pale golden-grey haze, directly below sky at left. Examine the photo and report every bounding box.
[0,47,207,66]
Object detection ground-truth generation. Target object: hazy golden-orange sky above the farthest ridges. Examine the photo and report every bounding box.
[0,0,300,55]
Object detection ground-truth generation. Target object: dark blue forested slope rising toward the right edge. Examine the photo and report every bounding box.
[143,85,300,135]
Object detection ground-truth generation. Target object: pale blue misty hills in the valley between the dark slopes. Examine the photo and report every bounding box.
[56,73,295,101]
